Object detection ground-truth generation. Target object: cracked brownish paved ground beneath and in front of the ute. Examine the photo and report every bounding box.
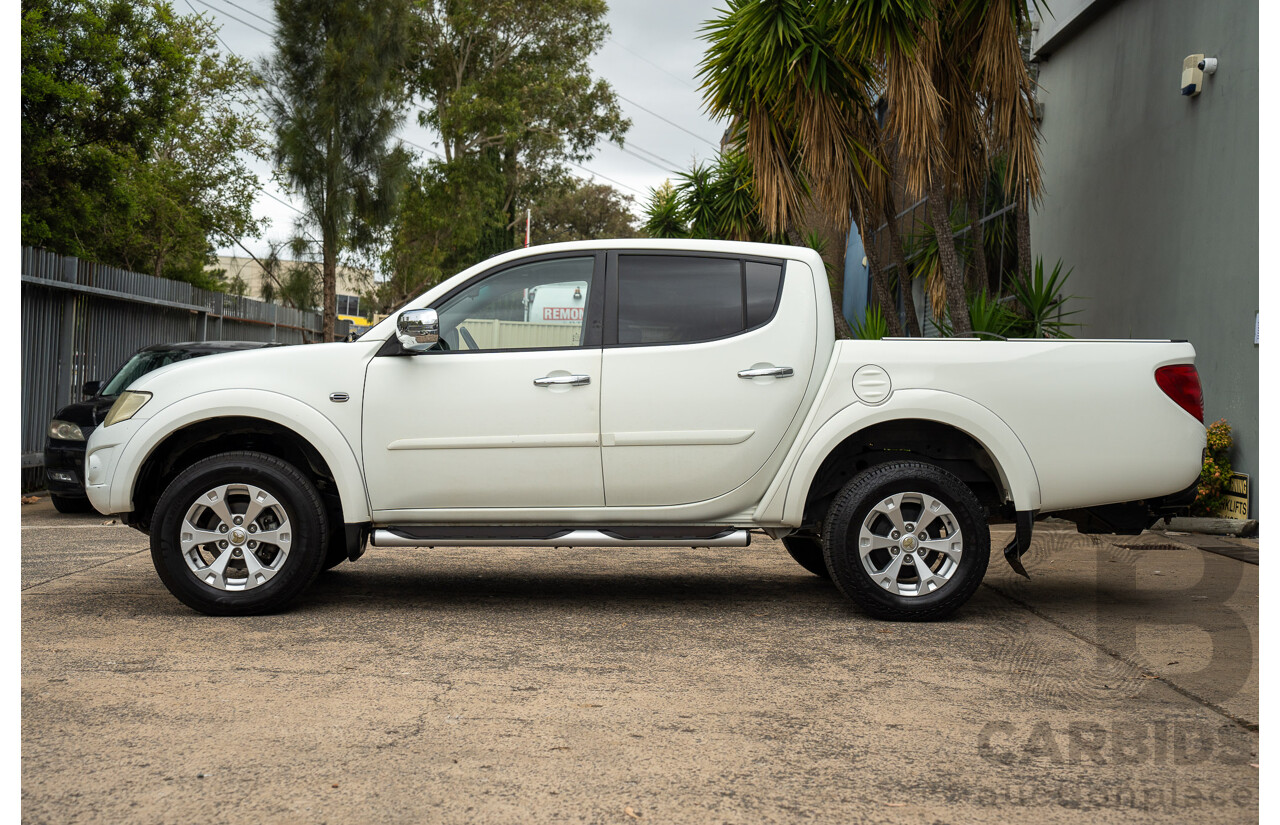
[22,499,1258,824]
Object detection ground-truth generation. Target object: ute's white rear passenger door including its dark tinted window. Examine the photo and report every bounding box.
[600,251,815,507]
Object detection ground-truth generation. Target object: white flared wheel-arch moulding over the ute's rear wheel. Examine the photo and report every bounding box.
[756,389,1041,526]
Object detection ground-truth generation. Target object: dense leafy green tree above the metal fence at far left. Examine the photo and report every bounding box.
[22,0,265,287]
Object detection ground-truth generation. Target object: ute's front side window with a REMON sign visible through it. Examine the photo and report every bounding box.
[436,256,595,350]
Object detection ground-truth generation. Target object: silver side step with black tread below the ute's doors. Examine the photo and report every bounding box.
[372,524,751,547]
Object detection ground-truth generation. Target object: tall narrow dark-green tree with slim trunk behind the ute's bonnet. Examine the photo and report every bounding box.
[262,0,411,340]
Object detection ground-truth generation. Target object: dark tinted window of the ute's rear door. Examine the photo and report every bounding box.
[618,255,782,344]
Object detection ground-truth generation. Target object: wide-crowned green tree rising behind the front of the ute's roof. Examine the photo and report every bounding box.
[411,0,630,248]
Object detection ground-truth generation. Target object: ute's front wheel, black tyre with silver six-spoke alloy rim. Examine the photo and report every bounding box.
[151,452,329,615]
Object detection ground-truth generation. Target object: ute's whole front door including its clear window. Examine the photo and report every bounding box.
[364,253,604,512]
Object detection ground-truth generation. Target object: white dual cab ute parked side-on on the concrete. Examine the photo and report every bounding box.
[86,239,1204,619]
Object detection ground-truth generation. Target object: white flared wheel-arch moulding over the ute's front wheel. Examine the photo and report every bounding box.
[90,389,370,524]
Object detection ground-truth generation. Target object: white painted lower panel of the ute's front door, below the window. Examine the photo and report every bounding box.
[364,349,604,510]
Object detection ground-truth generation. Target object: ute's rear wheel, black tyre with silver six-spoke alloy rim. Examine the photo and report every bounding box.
[823,462,991,622]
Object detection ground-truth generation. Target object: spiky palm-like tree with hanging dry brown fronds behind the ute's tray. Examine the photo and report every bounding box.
[700,0,1039,335]
